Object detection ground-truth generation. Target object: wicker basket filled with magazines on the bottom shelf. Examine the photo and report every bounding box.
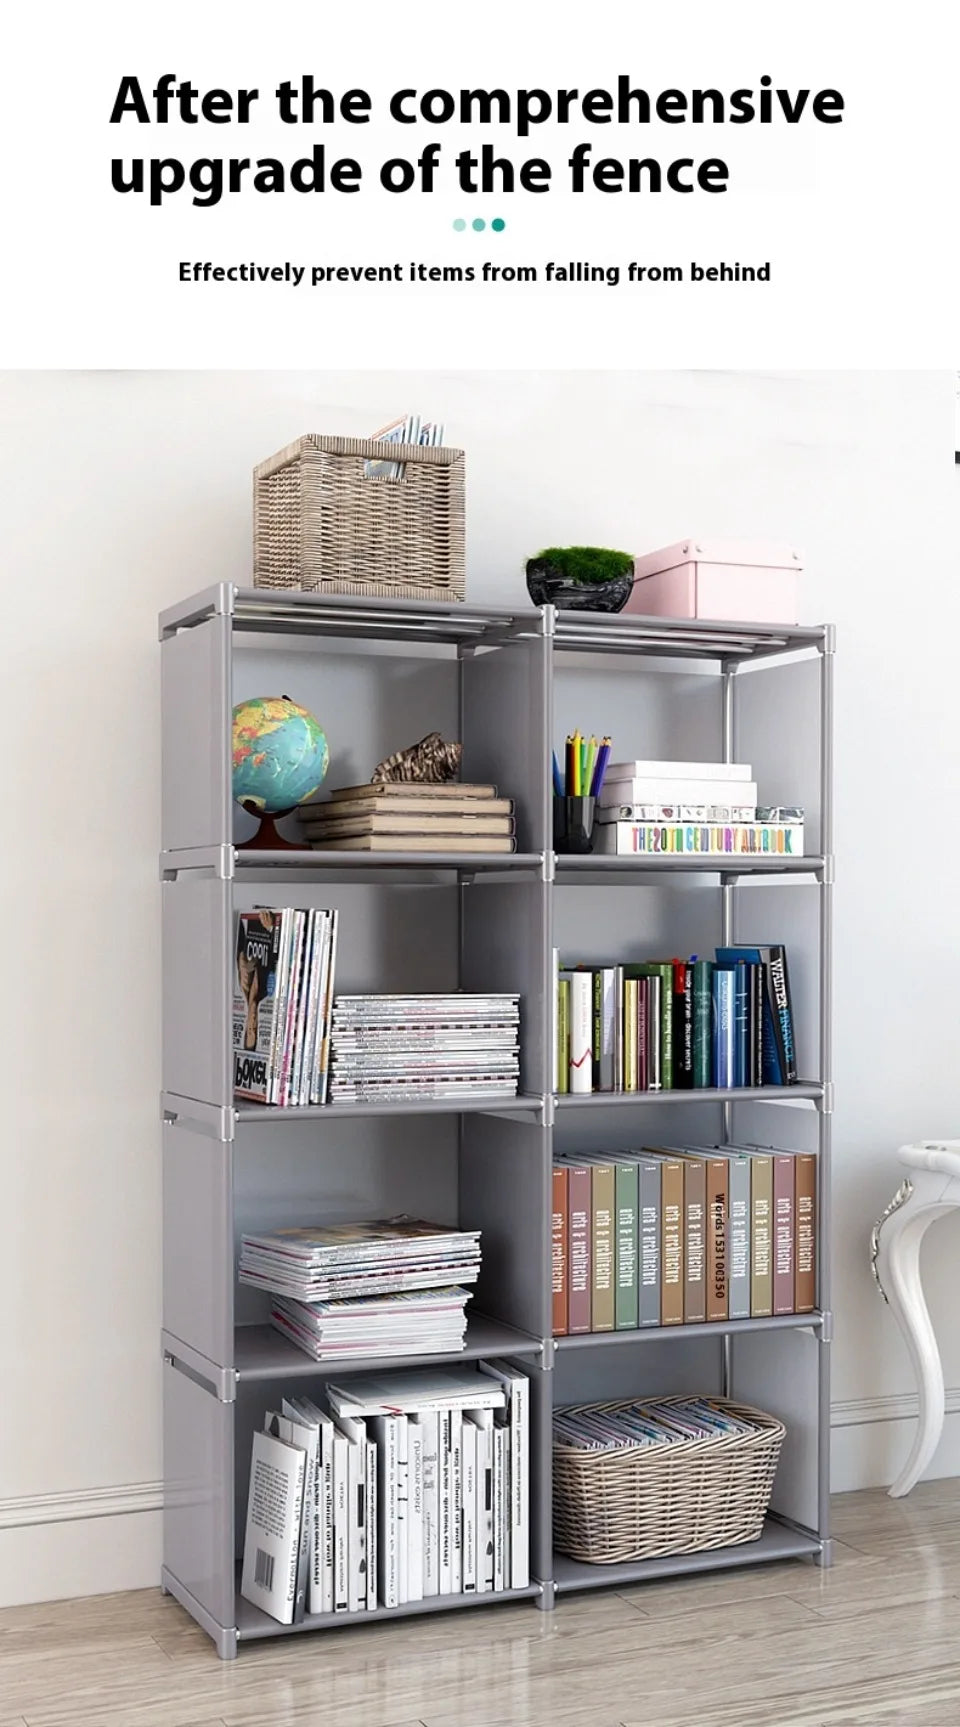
[553,1397,786,1565]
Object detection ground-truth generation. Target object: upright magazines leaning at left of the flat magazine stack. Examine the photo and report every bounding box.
[233,907,338,1105]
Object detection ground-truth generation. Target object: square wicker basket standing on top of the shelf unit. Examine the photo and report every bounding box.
[254,435,464,599]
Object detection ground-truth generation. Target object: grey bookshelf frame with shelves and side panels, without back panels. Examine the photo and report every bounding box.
[159,584,834,1660]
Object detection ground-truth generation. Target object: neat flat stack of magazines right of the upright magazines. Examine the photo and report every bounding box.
[330,991,520,1104]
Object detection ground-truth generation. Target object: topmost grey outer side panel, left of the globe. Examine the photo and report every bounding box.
[161,617,233,851]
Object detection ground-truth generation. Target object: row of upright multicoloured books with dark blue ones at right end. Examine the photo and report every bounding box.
[554,946,798,1091]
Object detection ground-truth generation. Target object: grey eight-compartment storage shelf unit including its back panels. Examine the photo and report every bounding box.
[159,584,834,1658]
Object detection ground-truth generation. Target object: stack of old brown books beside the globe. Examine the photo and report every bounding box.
[297,781,516,851]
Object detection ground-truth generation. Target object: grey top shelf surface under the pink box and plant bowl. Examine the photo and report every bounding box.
[554,611,827,661]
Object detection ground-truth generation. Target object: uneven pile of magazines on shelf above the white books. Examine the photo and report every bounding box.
[240,1218,480,1361]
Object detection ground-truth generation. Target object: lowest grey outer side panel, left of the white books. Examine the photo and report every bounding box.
[164,1361,237,1625]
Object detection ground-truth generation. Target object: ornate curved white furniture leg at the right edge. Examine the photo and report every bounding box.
[874,1171,957,1499]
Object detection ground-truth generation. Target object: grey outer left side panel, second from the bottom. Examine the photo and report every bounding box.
[162,1121,233,1374]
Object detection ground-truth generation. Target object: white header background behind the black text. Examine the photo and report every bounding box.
[0,0,960,368]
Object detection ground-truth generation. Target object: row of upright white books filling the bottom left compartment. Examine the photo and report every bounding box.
[240,1363,530,1625]
